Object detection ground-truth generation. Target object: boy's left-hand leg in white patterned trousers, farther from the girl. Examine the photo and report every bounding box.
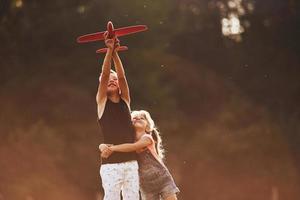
[100,163,123,200]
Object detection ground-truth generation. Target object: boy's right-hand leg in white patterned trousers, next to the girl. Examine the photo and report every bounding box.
[122,161,140,200]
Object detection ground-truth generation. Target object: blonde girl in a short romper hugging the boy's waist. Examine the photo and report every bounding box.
[99,110,179,200]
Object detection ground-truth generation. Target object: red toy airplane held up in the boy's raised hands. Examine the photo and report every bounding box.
[77,21,148,53]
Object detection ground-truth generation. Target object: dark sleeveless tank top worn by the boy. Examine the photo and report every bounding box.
[99,99,136,164]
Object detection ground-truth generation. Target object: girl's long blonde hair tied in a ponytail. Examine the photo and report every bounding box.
[131,110,164,159]
